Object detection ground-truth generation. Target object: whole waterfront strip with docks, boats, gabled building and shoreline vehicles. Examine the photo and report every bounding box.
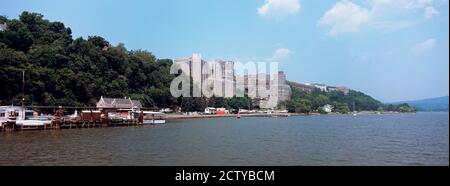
[0,97,292,132]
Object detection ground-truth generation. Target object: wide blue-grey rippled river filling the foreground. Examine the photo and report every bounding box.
[0,112,449,166]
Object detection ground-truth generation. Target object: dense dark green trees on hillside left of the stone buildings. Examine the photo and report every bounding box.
[0,12,177,107]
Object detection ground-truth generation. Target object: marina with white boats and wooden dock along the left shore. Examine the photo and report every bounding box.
[0,106,166,132]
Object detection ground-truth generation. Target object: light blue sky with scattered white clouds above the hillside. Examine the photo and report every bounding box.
[0,0,449,102]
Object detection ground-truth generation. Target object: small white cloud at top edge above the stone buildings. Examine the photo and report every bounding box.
[257,0,300,19]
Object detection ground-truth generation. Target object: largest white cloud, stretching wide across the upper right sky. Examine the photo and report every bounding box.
[318,0,442,35]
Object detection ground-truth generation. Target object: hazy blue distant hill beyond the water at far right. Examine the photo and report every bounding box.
[392,96,449,111]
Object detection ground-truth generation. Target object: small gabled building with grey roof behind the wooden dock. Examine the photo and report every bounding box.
[97,96,142,110]
